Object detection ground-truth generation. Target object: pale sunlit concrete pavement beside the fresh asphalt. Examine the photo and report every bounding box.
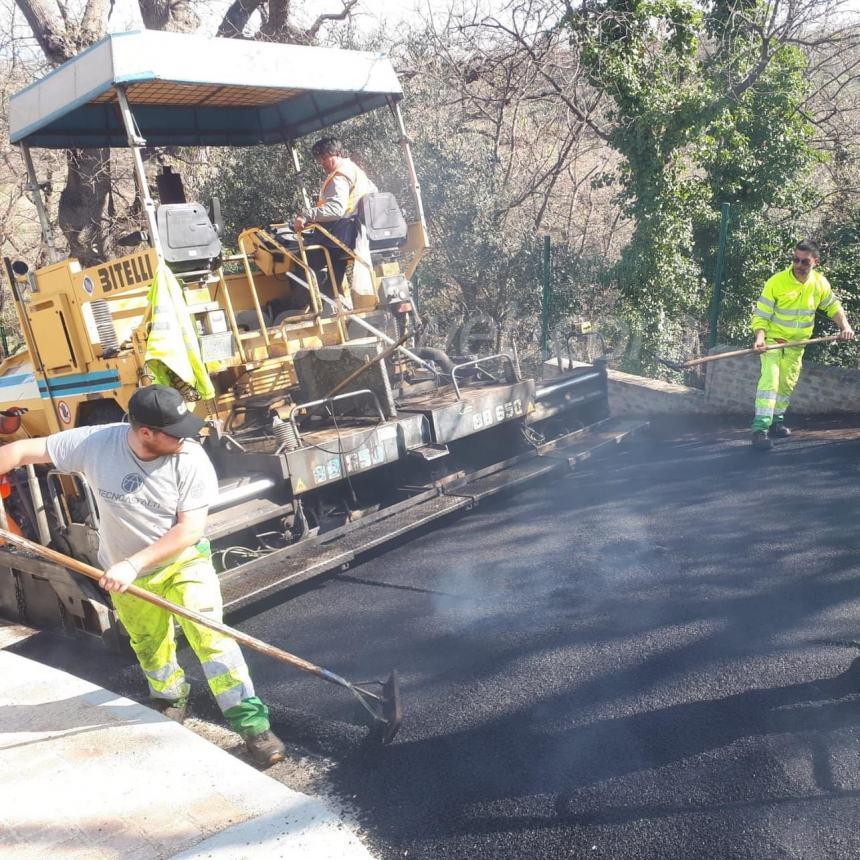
[0,640,372,860]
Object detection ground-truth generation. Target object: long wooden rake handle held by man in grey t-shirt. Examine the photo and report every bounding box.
[0,529,354,690]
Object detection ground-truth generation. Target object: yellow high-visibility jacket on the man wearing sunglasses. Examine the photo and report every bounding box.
[750,266,842,340]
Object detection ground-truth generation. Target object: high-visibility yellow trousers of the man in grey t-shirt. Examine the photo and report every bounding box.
[111,542,269,734]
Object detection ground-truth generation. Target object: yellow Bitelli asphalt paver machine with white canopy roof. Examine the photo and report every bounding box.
[0,31,639,644]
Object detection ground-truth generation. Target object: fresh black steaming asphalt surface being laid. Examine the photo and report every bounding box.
[11,414,860,860]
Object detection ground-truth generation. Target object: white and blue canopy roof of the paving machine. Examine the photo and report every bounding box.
[9,30,402,148]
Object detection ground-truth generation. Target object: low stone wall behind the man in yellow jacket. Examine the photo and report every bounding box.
[544,346,860,417]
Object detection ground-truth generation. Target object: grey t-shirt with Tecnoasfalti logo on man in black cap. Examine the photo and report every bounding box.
[47,424,218,567]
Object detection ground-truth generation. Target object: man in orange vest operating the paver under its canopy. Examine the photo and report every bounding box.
[293,137,377,296]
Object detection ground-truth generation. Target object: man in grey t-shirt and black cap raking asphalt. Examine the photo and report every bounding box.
[0,385,284,766]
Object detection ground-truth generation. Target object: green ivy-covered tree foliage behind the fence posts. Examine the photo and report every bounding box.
[565,0,818,364]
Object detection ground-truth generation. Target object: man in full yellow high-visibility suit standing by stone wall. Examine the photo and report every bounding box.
[751,240,854,451]
